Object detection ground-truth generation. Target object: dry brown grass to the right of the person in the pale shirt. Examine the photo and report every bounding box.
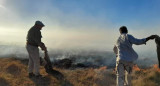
[132,65,160,86]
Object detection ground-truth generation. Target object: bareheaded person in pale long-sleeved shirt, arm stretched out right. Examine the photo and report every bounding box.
[113,26,156,86]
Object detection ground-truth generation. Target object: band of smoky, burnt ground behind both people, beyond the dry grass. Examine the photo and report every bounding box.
[0,45,158,68]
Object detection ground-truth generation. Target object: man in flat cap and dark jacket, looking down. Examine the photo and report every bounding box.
[26,21,46,78]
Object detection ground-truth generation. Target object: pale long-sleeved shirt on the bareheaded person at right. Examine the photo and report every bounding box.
[113,33,146,62]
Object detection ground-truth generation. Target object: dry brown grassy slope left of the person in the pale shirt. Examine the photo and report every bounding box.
[0,58,115,86]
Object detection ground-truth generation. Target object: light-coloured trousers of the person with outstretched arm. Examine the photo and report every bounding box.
[116,61,133,86]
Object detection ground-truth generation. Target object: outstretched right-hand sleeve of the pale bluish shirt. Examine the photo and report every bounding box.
[128,35,146,45]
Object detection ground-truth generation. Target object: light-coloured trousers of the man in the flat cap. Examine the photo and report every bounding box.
[26,45,40,75]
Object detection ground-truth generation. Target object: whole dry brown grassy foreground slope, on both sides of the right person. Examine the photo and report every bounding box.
[0,58,160,86]
